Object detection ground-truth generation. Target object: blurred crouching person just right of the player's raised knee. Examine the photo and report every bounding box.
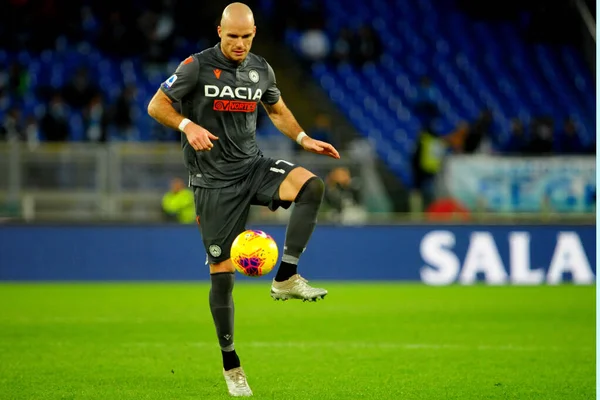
[324,168,367,225]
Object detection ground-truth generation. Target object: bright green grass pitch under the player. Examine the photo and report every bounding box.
[0,278,596,400]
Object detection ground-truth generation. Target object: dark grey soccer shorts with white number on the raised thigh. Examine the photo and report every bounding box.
[194,157,297,264]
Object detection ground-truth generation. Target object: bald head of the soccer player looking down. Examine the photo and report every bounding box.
[217,3,256,62]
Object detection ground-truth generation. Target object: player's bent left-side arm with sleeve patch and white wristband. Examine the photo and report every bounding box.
[148,57,218,151]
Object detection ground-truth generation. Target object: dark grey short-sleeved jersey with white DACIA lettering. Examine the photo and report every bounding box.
[161,44,280,188]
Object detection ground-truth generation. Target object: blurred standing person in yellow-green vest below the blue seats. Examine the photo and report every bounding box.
[412,129,446,208]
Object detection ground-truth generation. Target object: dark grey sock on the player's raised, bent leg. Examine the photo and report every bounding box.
[275,176,325,282]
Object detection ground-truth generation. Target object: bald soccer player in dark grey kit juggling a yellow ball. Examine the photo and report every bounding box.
[148,3,340,396]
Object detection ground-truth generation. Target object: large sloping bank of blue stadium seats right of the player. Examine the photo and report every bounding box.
[286,0,596,181]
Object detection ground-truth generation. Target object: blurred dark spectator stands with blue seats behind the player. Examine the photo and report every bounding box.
[0,0,596,220]
